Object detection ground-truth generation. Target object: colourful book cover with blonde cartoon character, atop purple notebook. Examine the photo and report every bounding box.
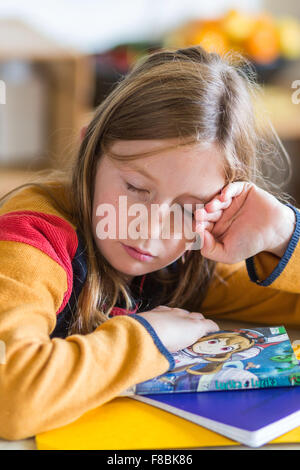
[124,326,300,396]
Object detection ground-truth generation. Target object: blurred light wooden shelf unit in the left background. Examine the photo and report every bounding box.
[0,20,94,197]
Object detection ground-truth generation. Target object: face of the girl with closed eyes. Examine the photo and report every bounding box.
[93,139,225,281]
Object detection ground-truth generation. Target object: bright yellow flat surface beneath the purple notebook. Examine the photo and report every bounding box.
[36,321,300,450]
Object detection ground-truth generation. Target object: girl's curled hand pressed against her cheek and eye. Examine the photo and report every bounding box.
[196,181,295,264]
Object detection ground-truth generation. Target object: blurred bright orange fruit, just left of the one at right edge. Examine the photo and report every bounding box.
[245,14,280,64]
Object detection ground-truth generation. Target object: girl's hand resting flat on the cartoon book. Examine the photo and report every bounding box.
[138,305,219,352]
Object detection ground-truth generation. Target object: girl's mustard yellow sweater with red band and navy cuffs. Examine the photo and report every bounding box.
[0,182,300,439]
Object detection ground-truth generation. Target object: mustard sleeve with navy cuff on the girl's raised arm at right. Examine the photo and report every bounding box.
[201,206,300,328]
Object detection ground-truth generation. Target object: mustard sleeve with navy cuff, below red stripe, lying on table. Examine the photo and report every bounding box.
[0,231,170,440]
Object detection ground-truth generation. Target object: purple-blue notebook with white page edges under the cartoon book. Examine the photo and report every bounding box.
[131,387,300,447]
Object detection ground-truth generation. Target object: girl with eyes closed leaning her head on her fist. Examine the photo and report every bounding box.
[0,47,300,439]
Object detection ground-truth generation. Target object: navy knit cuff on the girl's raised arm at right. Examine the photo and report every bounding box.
[246,203,300,287]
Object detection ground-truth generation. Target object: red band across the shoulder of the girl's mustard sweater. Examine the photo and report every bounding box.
[0,211,78,314]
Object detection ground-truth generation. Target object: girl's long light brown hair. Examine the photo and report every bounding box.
[0,46,294,334]
